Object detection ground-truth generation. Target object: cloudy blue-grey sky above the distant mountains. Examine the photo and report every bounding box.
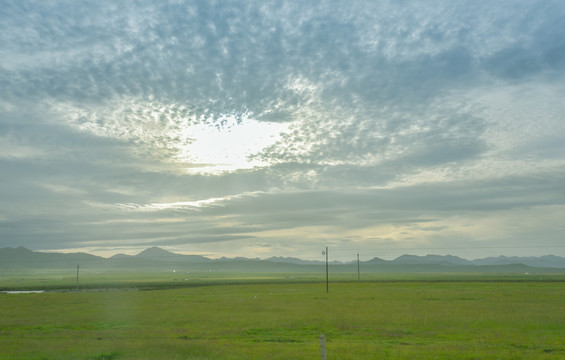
[0,0,565,260]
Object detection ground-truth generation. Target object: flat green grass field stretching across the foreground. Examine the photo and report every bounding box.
[0,275,565,360]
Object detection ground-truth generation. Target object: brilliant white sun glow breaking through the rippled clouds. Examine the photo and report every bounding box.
[57,98,289,174]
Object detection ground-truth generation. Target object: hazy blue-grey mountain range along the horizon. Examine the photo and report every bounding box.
[0,247,565,272]
